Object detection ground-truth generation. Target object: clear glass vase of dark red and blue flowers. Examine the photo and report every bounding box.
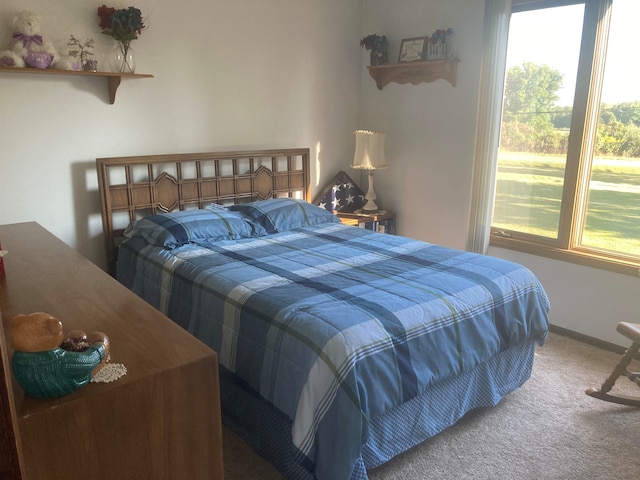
[98,5,145,73]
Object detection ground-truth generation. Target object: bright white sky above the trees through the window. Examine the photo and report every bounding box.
[507,0,640,106]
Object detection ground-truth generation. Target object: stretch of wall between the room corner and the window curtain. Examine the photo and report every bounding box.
[360,0,484,249]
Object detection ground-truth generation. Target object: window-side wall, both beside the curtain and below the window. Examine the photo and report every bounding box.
[360,0,640,346]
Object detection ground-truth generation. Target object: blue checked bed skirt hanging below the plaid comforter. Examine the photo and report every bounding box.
[220,340,536,480]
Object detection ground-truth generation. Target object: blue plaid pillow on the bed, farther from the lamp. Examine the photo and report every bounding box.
[127,205,266,248]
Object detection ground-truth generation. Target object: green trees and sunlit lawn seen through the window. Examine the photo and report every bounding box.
[493,63,640,256]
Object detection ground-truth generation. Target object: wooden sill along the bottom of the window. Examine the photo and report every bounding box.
[489,234,640,277]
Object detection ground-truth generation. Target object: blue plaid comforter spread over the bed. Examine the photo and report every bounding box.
[118,224,549,480]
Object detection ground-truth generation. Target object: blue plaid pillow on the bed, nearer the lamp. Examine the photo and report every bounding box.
[229,198,340,233]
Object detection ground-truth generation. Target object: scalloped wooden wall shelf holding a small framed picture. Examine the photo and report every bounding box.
[367,60,458,90]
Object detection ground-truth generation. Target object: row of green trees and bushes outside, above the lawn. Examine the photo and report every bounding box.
[500,62,640,158]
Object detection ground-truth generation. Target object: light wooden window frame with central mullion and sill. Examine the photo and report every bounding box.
[489,0,640,276]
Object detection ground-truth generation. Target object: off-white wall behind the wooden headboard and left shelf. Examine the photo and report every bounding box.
[0,0,362,266]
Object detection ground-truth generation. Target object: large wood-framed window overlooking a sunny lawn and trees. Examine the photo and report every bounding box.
[491,0,640,275]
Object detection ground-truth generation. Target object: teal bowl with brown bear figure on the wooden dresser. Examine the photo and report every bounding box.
[11,312,110,398]
